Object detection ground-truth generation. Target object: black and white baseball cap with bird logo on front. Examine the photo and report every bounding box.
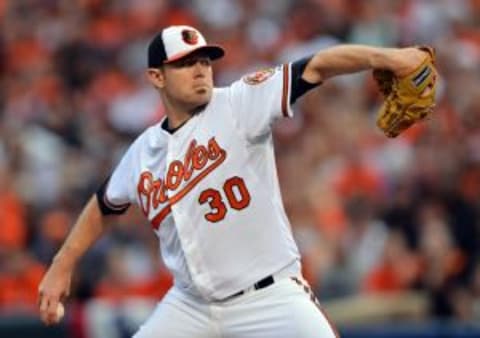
[148,25,225,68]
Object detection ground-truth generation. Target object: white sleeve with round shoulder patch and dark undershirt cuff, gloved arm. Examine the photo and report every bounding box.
[229,57,319,139]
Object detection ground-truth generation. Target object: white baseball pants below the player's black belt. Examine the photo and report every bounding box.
[134,277,339,338]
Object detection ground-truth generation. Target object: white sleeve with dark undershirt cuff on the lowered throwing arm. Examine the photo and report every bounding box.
[97,144,135,215]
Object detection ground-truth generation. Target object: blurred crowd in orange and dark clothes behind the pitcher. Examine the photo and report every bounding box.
[0,0,480,334]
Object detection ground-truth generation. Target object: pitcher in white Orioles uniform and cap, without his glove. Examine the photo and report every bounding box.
[39,26,432,338]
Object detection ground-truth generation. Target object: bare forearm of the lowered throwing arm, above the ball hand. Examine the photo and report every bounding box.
[53,195,105,268]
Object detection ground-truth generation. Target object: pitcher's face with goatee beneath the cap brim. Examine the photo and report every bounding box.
[147,54,213,109]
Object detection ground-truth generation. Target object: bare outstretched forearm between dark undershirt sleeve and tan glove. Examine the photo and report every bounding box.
[304,45,398,83]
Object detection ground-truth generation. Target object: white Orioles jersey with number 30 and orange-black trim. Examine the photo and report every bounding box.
[101,64,300,300]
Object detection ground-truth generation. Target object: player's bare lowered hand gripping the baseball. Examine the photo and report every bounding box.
[38,261,73,325]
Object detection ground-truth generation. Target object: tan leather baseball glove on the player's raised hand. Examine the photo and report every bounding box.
[373,47,437,137]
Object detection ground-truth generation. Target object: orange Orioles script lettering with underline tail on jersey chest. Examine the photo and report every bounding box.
[137,137,227,229]
